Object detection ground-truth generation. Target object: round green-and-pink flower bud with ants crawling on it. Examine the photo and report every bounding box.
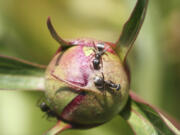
[45,39,129,127]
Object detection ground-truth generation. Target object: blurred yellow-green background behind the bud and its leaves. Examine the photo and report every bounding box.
[0,0,180,135]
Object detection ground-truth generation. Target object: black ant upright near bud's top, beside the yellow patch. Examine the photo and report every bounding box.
[92,43,108,70]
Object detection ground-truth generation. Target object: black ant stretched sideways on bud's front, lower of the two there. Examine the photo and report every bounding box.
[94,73,121,91]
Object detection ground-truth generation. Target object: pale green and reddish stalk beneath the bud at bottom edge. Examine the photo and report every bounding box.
[44,121,72,135]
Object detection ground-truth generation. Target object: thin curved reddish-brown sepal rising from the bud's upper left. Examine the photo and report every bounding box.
[47,17,70,50]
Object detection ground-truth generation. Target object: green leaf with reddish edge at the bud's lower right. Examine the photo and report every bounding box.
[120,92,180,135]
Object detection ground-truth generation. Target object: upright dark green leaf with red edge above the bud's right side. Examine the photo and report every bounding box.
[115,0,148,61]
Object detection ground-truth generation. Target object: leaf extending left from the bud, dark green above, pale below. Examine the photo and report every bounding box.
[0,55,45,90]
